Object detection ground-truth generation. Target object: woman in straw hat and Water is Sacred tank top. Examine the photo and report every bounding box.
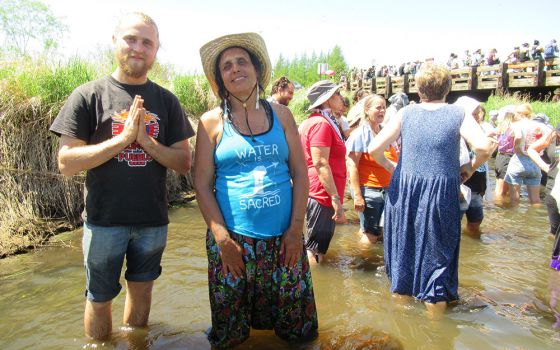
[195,33,317,347]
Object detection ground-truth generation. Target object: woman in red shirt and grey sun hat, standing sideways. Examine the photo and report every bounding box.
[300,80,346,263]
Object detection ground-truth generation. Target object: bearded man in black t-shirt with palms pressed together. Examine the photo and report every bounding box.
[50,13,194,339]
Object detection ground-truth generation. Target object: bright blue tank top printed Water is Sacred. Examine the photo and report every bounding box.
[214,108,292,239]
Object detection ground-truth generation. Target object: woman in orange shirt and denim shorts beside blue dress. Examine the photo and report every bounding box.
[346,95,398,243]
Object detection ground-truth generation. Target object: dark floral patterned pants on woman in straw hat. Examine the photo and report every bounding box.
[206,230,318,348]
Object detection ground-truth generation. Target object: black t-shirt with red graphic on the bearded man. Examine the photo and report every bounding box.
[50,76,194,226]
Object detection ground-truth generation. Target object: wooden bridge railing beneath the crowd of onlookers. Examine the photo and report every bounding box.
[346,58,560,98]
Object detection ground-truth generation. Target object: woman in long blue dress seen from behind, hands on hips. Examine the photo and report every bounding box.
[370,64,492,312]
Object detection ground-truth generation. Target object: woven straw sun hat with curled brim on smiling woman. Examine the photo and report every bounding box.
[200,33,272,97]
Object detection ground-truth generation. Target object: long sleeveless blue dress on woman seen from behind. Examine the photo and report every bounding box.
[384,105,464,303]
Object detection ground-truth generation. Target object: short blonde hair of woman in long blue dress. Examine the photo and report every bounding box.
[414,63,451,102]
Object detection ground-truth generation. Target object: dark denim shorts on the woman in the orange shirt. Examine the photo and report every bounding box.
[352,186,385,236]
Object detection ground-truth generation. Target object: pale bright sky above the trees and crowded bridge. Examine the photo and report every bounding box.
[43,0,560,72]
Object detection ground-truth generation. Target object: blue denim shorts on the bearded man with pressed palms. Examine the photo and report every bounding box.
[82,223,167,302]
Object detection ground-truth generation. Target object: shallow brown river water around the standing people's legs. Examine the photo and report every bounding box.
[0,196,560,349]
